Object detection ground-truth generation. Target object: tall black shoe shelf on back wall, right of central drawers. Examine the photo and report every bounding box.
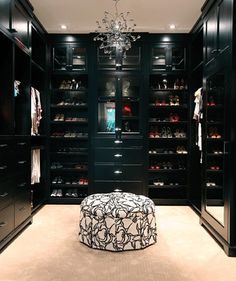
[148,73,189,203]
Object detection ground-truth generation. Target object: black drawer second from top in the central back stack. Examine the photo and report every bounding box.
[95,147,143,164]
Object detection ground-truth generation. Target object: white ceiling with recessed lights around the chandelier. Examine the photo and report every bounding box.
[30,0,205,33]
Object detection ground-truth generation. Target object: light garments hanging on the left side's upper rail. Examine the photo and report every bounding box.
[31,87,42,136]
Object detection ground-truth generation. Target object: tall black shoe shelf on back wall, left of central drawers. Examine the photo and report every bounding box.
[50,73,89,204]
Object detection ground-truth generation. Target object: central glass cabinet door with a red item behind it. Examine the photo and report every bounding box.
[121,77,140,133]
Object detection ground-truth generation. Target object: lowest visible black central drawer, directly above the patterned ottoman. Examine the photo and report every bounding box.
[94,181,143,194]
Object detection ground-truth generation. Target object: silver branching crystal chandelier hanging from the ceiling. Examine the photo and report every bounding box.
[94,0,140,58]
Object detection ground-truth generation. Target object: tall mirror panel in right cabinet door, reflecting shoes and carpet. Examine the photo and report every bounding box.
[204,70,227,225]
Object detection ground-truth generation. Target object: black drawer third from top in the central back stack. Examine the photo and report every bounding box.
[94,164,143,180]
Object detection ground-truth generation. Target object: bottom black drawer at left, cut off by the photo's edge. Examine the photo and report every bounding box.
[0,202,14,241]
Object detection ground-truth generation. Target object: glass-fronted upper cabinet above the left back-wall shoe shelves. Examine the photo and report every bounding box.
[53,43,87,71]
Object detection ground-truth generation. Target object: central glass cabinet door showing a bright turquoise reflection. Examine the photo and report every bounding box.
[98,77,117,133]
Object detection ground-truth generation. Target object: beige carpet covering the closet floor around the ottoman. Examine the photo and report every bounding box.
[0,205,236,281]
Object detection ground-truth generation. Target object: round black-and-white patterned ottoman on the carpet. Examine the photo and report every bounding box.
[79,192,157,251]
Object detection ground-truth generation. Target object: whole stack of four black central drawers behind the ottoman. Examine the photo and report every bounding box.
[92,135,145,194]
